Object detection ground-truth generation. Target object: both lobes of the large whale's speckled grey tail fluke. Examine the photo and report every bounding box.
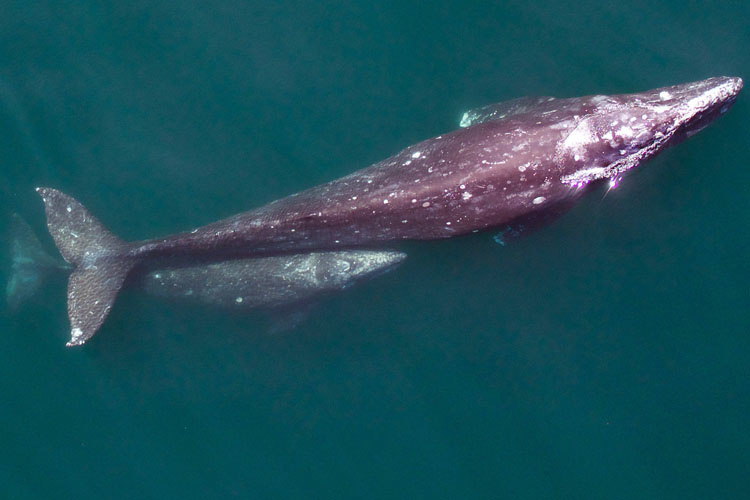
[36,187,137,346]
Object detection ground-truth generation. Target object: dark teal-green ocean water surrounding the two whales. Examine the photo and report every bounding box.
[0,0,750,499]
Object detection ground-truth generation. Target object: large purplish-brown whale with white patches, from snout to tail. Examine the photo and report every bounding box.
[38,77,742,345]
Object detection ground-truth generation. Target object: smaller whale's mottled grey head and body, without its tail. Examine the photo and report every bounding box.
[138,250,406,310]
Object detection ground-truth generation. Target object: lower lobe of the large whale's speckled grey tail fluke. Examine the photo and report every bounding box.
[66,260,132,347]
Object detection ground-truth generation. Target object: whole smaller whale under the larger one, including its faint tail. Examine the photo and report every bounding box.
[6,214,406,318]
